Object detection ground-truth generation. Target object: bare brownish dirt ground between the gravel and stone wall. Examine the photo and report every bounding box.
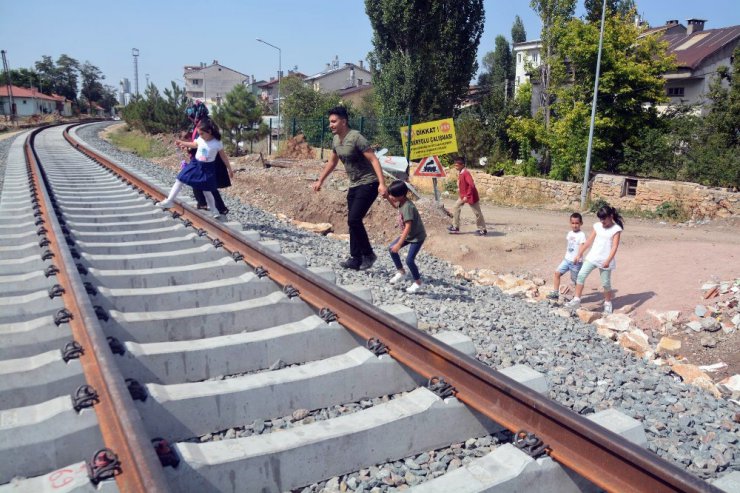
[137,134,740,381]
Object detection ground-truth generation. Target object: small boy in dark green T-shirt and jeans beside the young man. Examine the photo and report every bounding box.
[388,180,427,293]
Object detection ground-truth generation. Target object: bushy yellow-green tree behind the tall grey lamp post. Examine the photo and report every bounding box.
[509,11,674,180]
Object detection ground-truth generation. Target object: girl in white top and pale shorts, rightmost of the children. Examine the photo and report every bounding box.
[565,205,624,315]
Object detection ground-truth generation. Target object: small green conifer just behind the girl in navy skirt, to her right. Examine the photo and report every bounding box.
[213,84,269,156]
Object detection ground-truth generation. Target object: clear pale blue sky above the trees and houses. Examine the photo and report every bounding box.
[0,0,740,90]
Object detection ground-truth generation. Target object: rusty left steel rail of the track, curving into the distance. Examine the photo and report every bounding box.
[24,126,170,493]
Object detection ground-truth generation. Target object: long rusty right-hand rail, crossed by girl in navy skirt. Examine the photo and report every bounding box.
[67,123,720,493]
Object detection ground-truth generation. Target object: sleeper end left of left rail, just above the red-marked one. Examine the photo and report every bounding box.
[0,396,104,484]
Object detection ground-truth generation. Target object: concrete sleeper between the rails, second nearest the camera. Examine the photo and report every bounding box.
[164,389,497,491]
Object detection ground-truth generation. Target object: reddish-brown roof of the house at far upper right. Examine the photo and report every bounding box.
[661,26,740,70]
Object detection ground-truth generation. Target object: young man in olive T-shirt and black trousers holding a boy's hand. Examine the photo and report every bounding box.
[313,106,388,270]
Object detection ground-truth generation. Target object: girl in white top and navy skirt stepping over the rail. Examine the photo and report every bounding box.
[156,118,233,217]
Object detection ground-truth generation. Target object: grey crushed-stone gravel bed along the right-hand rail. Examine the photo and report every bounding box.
[8,124,740,492]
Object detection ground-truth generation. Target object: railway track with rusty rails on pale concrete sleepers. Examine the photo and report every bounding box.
[0,127,718,492]
